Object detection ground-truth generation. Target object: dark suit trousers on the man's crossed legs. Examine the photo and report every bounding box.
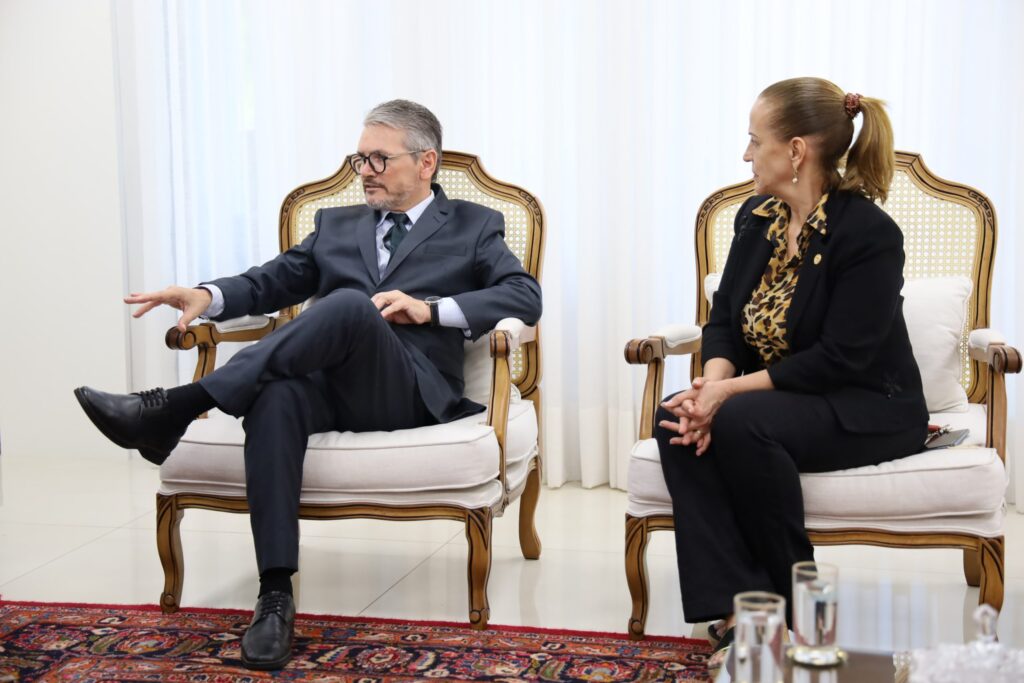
[200,290,435,573]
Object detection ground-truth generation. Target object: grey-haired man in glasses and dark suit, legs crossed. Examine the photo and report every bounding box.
[76,100,541,669]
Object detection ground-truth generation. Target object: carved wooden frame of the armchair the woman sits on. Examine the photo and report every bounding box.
[625,152,1021,639]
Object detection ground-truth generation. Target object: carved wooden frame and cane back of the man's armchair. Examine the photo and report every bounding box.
[157,151,545,629]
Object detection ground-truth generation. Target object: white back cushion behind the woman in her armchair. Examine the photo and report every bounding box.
[703,272,972,413]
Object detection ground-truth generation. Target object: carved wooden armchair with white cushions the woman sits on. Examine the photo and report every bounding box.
[626,153,1021,639]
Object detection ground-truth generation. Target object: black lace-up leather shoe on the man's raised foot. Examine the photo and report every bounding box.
[75,387,188,465]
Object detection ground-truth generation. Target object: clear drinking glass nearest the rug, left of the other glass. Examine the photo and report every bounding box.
[732,591,785,683]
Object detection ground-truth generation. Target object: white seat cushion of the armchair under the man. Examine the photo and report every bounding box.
[160,400,538,504]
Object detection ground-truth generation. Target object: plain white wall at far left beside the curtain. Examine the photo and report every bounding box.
[0,0,128,458]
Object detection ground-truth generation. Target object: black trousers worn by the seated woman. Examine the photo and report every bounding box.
[654,391,928,623]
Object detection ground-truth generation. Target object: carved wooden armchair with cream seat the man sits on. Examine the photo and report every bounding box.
[157,152,545,629]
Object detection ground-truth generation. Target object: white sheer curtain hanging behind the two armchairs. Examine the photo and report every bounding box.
[114,0,1024,487]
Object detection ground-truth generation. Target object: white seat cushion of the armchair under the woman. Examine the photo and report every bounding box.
[627,404,1007,536]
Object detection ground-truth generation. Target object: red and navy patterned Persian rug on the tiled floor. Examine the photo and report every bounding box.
[0,601,710,683]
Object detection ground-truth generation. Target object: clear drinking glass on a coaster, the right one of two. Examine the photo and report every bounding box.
[791,561,842,667]
